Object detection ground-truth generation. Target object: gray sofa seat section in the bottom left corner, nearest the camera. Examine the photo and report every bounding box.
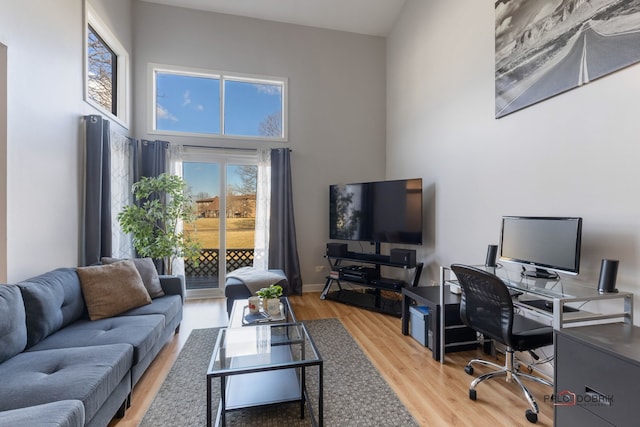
[0,400,84,427]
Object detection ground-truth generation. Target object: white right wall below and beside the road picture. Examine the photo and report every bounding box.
[387,0,640,310]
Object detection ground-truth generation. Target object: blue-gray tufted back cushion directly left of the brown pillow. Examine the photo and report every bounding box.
[18,268,85,348]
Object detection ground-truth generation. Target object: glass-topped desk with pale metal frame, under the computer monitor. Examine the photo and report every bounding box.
[439,264,633,363]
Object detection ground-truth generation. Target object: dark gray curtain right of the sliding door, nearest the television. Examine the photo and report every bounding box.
[269,148,302,295]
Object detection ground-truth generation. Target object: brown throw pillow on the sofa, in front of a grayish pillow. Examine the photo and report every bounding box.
[77,261,151,320]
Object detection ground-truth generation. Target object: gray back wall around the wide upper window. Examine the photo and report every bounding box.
[133,2,386,285]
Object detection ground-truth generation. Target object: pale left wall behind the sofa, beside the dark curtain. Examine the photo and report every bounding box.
[0,0,131,282]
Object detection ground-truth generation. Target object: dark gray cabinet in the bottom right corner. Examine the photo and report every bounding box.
[554,323,640,427]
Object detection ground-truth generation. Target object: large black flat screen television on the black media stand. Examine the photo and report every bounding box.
[329,178,422,252]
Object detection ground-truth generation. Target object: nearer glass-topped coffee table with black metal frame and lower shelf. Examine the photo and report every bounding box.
[207,323,323,427]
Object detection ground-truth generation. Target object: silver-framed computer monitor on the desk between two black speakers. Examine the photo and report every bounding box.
[500,216,582,279]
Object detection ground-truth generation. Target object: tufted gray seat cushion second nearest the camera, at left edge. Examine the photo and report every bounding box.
[0,344,133,420]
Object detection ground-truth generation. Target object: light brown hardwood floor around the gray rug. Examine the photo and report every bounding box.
[110,293,553,427]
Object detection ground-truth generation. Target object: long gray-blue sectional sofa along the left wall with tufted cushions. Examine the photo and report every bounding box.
[0,266,185,427]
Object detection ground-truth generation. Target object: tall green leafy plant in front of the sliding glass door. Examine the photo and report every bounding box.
[118,174,201,274]
